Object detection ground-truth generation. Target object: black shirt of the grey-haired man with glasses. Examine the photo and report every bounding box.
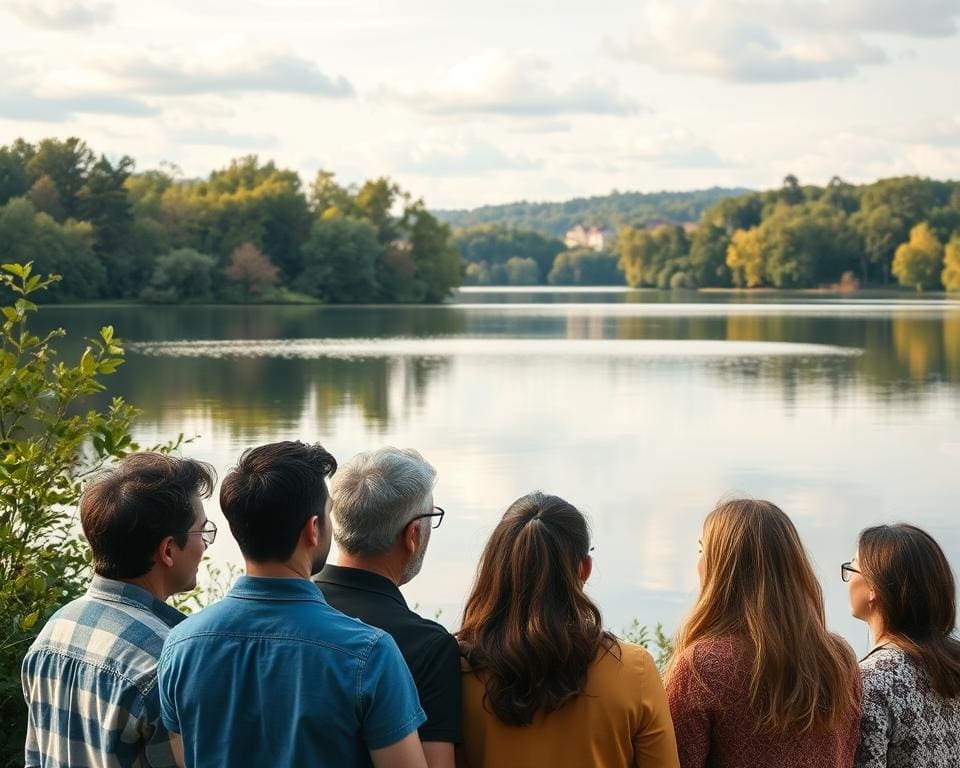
[313,565,461,743]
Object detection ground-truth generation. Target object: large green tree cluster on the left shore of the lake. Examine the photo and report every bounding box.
[0,138,462,303]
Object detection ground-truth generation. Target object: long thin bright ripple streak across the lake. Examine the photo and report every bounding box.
[128,338,862,359]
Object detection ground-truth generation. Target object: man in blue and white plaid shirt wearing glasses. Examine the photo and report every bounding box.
[22,453,216,768]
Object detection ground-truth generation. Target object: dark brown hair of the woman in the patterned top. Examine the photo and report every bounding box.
[857,523,960,699]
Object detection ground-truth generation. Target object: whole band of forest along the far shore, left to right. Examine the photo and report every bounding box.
[0,138,960,304]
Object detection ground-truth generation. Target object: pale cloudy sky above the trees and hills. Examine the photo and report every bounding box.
[0,0,960,207]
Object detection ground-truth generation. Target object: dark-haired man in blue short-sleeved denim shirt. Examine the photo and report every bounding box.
[158,442,426,768]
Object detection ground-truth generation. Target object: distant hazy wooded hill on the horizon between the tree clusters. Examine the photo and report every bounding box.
[432,187,751,237]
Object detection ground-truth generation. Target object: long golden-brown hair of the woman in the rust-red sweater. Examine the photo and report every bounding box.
[667,499,860,735]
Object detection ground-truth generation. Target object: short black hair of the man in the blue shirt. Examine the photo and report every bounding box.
[220,441,337,563]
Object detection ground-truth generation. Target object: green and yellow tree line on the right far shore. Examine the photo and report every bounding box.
[617,175,960,291]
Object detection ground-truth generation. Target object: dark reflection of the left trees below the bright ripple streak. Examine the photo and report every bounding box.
[110,355,449,437]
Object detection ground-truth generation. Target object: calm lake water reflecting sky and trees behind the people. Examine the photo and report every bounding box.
[42,290,960,650]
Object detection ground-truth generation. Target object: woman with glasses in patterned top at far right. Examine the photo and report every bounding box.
[840,524,960,768]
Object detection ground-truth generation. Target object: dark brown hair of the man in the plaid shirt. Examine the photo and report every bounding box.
[80,453,217,579]
